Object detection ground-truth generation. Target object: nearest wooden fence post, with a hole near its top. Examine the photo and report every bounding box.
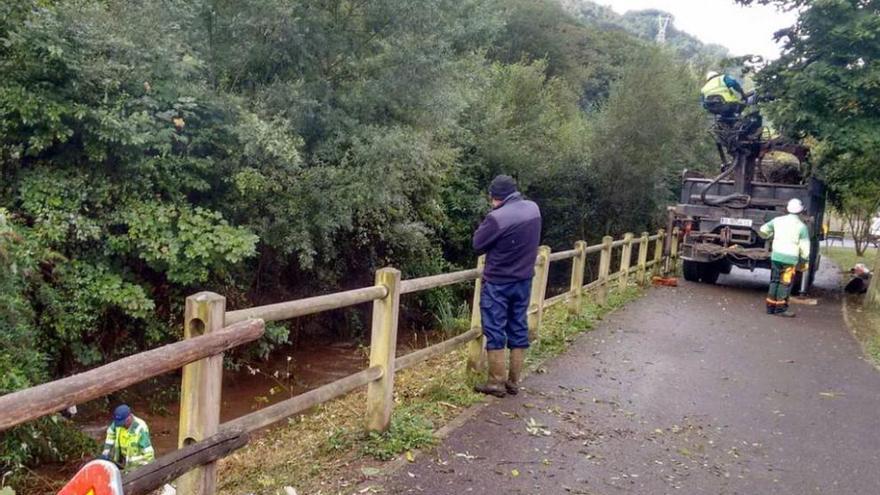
[177,292,226,495]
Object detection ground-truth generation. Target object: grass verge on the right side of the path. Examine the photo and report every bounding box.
[822,247,880,369]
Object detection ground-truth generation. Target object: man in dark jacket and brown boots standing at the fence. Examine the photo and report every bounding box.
[474,175,541,397]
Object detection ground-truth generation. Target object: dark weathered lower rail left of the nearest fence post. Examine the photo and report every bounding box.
[122,431,248,495]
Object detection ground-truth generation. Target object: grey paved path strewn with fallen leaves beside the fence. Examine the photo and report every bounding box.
[384,267,880,495]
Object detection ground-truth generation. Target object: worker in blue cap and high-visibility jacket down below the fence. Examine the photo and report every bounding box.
[100,404,156,472]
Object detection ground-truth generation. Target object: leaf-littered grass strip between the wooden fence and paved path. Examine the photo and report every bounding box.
[219,287,642,495]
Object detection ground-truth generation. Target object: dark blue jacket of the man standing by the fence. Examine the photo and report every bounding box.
[474,193,541,284]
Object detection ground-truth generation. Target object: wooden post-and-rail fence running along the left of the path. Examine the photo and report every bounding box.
[0,230,678,495]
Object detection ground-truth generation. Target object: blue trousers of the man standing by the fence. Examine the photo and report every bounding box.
[480,279,532,351]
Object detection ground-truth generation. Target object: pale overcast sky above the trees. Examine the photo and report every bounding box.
[594,0,797,59]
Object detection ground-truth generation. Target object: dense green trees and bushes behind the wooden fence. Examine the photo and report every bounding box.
[0,0,711,476]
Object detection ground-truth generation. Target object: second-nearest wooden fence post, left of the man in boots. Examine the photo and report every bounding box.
[367,267,400,431]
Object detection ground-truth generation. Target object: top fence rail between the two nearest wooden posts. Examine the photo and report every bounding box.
[226,285,388,325]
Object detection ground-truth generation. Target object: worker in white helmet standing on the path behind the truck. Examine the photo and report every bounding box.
[758,198,810,317]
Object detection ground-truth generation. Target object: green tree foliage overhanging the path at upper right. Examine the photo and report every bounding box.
[741,0,880,251]
